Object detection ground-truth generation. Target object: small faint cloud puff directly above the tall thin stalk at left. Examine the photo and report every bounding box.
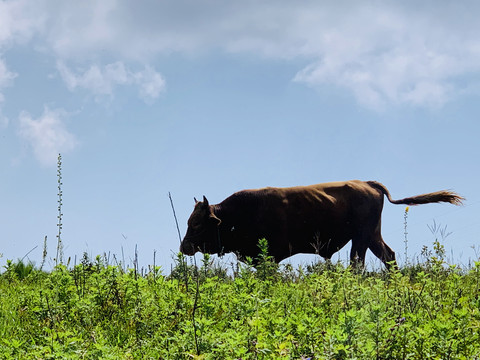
[19,107,78,166]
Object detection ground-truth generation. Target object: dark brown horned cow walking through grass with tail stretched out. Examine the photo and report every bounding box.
[180,180,464,267]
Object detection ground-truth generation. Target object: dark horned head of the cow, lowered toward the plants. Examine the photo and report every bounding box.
[180,196,222,255]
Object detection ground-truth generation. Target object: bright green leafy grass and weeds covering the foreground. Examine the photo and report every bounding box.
[0,248,480,359]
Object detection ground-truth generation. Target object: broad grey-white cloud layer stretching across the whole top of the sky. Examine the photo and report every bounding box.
[4,0,480,109]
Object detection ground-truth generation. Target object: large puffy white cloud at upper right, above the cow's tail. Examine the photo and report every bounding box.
[288,6,480,109]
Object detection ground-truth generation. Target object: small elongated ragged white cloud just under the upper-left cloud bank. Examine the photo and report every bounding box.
[57,61,165,102]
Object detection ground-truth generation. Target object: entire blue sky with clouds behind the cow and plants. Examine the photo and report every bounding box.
[0,0,480,272]
